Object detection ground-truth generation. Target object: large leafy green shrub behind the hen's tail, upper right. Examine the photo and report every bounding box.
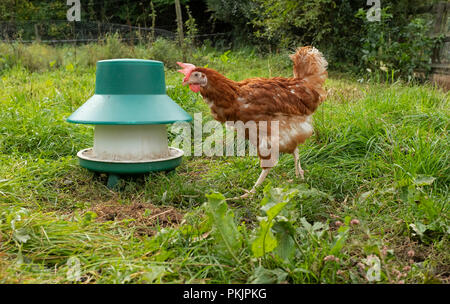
[244,0,434,81]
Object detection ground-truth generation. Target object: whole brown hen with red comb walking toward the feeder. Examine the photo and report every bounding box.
[178,46,328,198]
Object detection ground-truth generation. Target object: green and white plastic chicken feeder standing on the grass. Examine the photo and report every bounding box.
[67,59,192,188]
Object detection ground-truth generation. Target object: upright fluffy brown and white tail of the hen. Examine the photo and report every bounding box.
[289,46,328,101]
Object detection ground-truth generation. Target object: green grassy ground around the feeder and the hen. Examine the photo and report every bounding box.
[0,41,450,283]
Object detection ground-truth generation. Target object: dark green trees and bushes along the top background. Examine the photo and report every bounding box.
[0,0,442,80]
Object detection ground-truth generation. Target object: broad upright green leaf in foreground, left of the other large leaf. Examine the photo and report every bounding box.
[205,193,242,262]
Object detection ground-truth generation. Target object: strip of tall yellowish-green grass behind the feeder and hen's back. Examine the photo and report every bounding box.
[0,34,291,78]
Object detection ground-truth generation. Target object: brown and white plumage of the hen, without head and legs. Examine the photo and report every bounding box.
[194,47,328,153]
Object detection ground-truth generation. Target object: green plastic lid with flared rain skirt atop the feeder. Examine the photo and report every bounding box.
[67,59,192,125]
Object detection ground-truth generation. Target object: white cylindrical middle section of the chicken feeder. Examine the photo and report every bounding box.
[93,125,169,161]
